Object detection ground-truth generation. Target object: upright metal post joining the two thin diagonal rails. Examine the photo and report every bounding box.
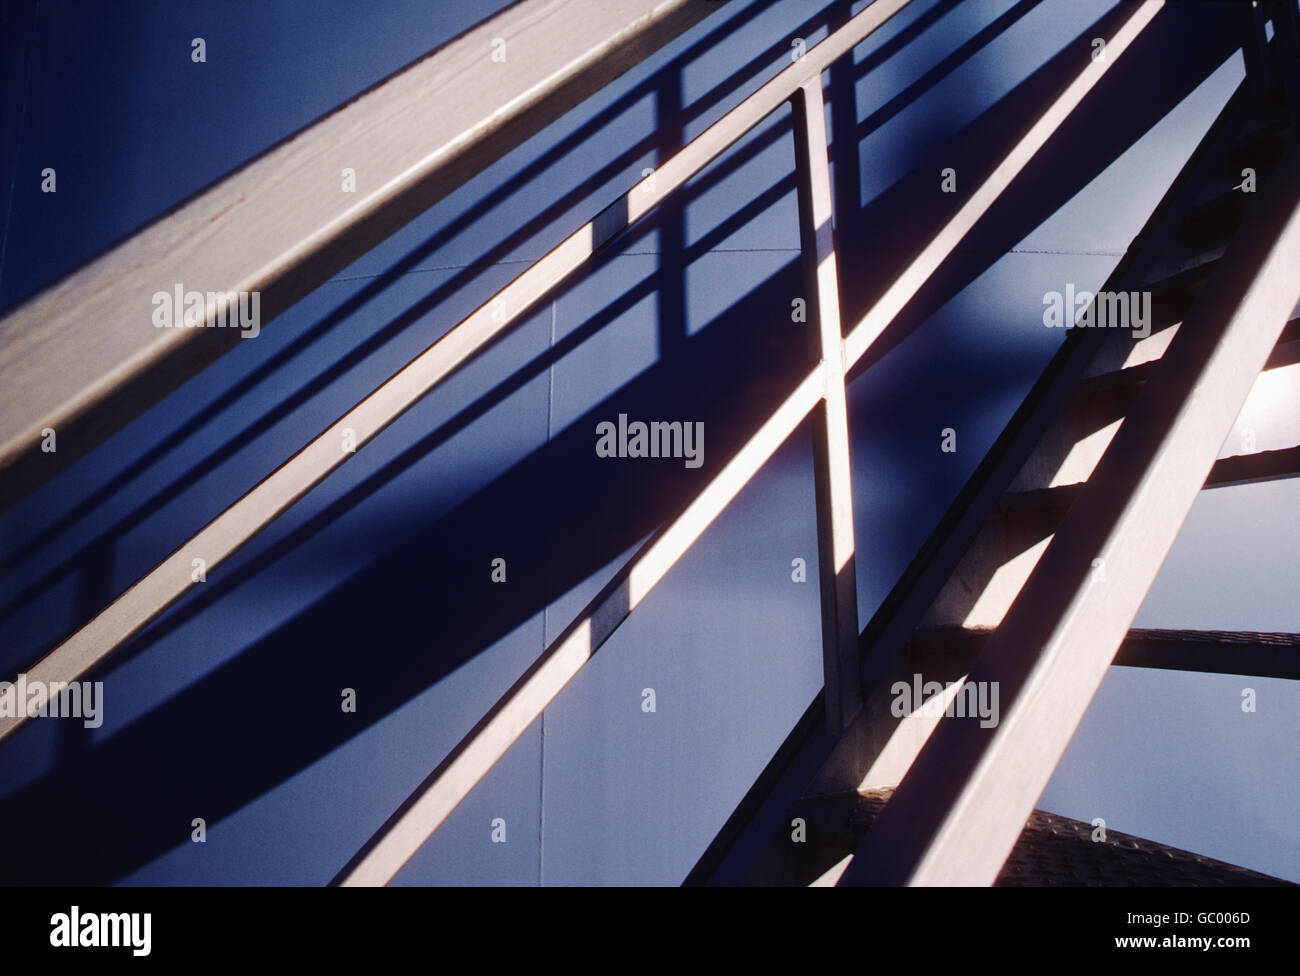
[792,75,862,733]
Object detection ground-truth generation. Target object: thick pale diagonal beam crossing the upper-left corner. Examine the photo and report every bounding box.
[0,0,712,508]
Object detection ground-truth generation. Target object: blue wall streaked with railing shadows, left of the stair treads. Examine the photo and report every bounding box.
[0,0,1289,884]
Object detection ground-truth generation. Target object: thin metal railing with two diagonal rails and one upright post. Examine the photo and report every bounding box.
[0,0,1164,885]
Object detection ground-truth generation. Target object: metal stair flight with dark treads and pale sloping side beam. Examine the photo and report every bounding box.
[689,17,1300,884]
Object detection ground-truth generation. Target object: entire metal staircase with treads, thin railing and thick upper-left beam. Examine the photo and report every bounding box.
[0,0,1300,885]
